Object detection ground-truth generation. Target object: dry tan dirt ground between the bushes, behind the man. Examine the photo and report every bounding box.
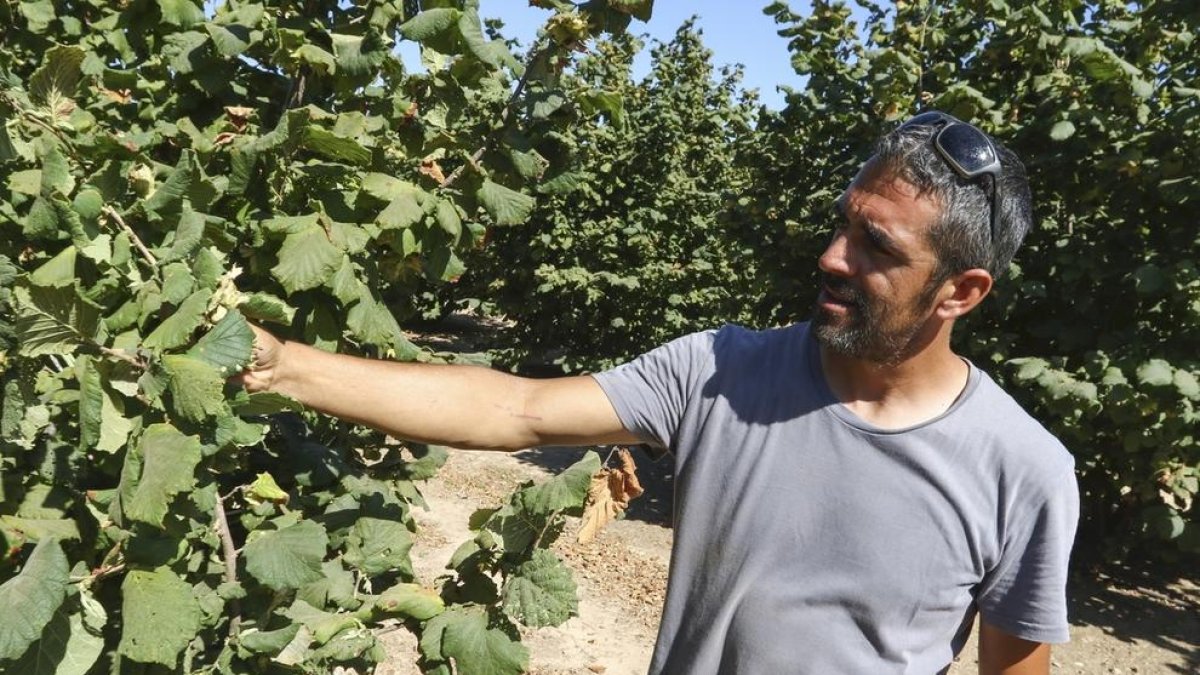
[377,448,1200,675]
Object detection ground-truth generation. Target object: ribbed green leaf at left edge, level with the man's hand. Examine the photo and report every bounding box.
[12,286,101,357]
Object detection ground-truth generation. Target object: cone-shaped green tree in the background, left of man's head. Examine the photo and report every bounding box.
[461,22,754,371]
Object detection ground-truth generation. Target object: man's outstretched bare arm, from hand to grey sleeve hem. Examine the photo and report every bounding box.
[236,327,640,450]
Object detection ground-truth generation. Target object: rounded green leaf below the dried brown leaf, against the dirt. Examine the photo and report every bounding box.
[503,549,580,628]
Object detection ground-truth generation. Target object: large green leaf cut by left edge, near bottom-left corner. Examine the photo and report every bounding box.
[0,538,71,661]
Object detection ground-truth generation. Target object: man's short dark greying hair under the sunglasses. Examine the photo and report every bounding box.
[872,119,1033,279]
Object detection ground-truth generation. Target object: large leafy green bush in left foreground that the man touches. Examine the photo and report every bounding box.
[0,0,649,673]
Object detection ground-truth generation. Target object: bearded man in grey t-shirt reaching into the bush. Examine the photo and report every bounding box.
[242,113,1078,675]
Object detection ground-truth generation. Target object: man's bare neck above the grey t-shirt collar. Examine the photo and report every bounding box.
[820,324,971,429]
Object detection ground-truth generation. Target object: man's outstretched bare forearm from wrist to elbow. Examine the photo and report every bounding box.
[270,342,539,449]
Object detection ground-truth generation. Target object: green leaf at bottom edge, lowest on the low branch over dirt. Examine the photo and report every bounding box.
[421,608,529,675]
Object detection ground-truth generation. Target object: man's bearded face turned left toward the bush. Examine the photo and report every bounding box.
[812,162,938,364]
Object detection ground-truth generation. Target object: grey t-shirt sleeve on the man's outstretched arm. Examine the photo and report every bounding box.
[593,330,714,449]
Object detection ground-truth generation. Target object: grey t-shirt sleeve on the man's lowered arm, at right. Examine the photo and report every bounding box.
[976,462,1079,643]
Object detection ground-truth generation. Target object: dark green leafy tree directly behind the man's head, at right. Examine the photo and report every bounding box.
[739,0,1200,557]
